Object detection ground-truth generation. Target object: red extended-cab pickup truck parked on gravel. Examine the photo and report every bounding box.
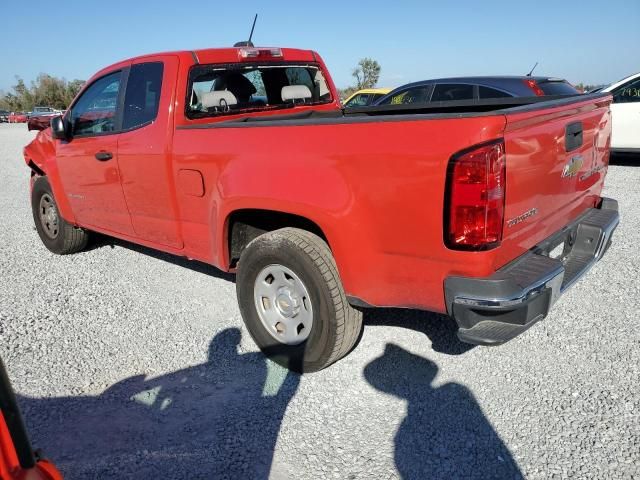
[24,47,619,371]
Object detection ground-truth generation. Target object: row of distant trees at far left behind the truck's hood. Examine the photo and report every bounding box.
[0,73,84,112]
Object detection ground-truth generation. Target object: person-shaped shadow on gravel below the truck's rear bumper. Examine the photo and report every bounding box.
[364,344,523,479]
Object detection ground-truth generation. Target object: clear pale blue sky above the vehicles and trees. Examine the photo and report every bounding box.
[0,0,640,91]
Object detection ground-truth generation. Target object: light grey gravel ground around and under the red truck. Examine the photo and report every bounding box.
[0,124,640,479]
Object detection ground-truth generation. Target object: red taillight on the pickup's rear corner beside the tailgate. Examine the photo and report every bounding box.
[444,141,506,250]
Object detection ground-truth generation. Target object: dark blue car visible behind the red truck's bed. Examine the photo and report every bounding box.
[375,76,581,105]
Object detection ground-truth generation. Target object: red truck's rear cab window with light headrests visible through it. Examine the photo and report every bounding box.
[186,64,332,118]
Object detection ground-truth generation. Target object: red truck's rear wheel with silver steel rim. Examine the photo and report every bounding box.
[236,228,362,372]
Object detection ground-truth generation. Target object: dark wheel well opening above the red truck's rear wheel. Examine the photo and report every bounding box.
[228,210,329,268]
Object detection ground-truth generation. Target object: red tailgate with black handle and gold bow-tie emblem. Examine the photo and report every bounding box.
[496,96,611,268]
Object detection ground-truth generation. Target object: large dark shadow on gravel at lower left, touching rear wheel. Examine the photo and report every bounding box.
[18,328,300,479]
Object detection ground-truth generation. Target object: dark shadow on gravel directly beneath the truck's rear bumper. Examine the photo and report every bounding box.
[364,308,475,355]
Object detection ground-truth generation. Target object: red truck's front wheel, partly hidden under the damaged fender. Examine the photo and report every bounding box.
[31,177,89,255]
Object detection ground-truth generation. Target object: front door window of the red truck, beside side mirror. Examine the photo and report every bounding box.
[71,72,121,135]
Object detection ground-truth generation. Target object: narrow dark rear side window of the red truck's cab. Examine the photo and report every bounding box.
[122,62,163,130]
